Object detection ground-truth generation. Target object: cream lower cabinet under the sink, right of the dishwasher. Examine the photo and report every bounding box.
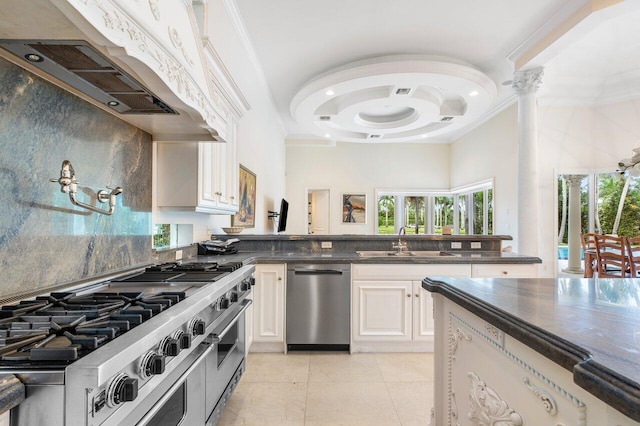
[351,264,471,352]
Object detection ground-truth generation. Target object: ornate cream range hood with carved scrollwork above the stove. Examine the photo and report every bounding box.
[0,0,248,141]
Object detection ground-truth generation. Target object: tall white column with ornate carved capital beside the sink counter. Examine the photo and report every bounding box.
[513,68,542,256]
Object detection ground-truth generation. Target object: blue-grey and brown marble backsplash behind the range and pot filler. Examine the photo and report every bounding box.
[0,58,153,297]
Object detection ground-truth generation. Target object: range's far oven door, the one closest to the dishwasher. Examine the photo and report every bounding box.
[205,299,252,425]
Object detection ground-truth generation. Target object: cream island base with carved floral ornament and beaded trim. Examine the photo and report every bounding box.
[431,293,638,426]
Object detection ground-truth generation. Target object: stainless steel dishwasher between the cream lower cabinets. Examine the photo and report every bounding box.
[286,264,351,350]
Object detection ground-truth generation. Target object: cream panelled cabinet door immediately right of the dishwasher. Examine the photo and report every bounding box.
[352,281,413,342]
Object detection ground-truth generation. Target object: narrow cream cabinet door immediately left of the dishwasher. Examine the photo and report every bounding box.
[253,264,286,343]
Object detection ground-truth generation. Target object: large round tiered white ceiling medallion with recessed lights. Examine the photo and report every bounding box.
[290,56,497,142]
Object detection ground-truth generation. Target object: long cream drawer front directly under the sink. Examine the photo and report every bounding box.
[352,264,471,280]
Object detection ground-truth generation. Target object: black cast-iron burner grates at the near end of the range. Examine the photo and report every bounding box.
[0,290,186,365]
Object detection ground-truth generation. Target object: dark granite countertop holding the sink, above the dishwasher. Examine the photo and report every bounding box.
[198,251,541,264]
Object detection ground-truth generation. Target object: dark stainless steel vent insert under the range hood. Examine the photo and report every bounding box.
[0,40,177,114]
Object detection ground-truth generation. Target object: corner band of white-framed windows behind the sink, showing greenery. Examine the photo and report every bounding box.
[376,180,493,235]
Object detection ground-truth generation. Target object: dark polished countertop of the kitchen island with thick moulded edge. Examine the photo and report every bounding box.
[422,277,640,421]
